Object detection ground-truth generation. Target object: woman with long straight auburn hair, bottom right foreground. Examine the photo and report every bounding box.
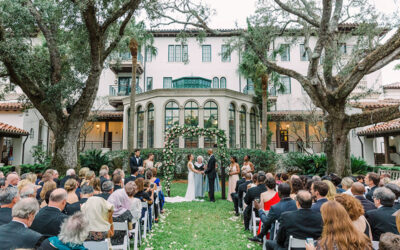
[306,201,372,250]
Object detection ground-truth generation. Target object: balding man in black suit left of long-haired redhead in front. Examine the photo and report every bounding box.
[265,190,323,250]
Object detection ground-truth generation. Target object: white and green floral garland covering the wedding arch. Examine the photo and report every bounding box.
[163,125,227,194]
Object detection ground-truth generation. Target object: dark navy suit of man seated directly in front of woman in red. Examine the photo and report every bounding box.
[258,197,297,239]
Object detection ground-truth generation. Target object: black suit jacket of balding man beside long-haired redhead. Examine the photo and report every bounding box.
[277,208,323,248]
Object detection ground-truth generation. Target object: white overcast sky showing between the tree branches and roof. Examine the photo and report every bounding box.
[202,0,400,85]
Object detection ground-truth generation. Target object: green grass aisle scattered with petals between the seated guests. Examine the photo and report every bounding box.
[141,183,262,249]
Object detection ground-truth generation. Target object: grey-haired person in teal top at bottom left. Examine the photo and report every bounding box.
[38,212,89,250]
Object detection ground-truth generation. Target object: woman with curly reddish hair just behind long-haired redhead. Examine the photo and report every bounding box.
[335,194,372,240]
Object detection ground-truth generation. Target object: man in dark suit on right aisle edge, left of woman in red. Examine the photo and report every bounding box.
[243,174,267,230]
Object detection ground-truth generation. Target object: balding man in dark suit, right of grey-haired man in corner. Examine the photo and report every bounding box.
[31,188,68,236]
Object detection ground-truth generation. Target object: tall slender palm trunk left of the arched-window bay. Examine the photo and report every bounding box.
[128,38,139,154]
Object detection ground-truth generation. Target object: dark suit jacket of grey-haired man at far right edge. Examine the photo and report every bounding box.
[365,206,399,241]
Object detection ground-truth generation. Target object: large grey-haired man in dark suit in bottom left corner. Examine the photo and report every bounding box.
[0,198,42,249]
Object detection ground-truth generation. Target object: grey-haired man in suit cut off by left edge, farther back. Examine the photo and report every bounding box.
[0,187,19,225]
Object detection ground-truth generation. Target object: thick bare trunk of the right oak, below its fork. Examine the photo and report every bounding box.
[324,114,351,177]
